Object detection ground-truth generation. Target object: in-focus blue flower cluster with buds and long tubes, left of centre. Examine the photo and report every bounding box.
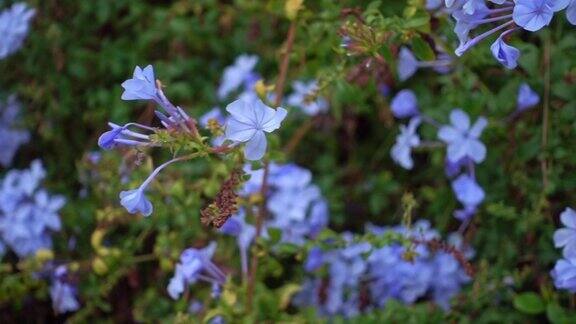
[98,59,288,216]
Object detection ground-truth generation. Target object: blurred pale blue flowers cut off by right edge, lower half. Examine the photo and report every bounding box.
[550,208,576,293]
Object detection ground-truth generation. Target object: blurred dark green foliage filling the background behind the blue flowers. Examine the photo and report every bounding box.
[0,0,576,323]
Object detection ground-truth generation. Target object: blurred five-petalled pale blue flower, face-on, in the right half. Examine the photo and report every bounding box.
[438,109,488,163]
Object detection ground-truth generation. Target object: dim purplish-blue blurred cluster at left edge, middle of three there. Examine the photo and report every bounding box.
[0,95,30,167]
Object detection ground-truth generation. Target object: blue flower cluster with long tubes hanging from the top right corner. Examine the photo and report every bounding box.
[446,0,576,69]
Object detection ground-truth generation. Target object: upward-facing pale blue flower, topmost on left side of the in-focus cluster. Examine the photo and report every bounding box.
[122,65,158,101]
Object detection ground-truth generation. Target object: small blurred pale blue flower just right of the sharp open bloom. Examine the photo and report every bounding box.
[288,80,328,116]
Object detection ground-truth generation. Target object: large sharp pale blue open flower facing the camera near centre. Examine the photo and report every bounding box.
[226,100,288,161]
